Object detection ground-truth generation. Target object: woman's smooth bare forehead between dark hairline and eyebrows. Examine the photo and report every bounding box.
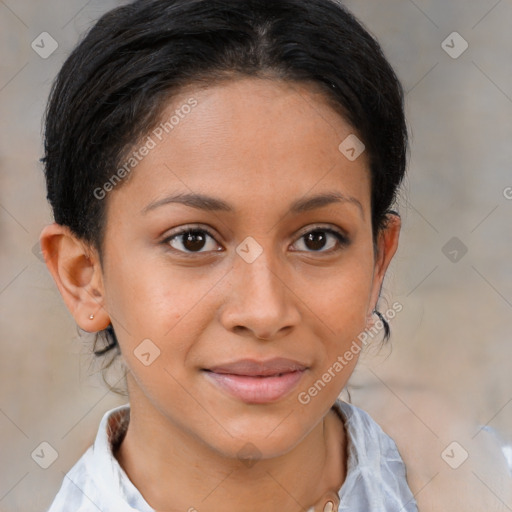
[106,78,369,216]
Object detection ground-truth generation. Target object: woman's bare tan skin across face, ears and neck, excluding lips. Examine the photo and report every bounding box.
[41,78,400,512]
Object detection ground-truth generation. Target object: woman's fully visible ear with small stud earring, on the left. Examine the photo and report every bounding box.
[39,223,110,332]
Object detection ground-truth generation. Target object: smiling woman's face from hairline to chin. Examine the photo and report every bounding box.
[97,79,397,458]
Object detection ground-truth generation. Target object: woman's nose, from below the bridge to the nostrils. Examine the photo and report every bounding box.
[220,249,301,340]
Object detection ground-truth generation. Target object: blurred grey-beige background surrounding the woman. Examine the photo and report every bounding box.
[0,0,512,512]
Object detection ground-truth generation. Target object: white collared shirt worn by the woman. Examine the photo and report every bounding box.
[47,400,418,512]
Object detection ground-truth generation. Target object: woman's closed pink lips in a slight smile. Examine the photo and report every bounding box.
[205,358,307,404]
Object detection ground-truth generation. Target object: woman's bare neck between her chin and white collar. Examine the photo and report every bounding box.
[116,382,346,512]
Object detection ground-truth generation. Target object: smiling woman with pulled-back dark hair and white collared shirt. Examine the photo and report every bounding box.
[41,0,417,512]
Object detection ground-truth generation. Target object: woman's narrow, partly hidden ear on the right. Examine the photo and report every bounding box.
[367,212,402,318]
